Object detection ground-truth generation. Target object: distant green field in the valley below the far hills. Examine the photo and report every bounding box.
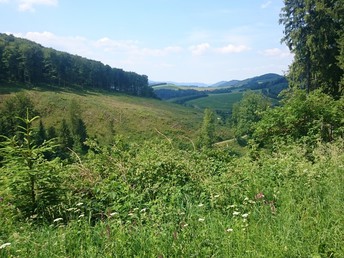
[185,92,243,111]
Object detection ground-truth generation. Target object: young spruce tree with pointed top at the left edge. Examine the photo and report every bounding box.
[0,111,61,220]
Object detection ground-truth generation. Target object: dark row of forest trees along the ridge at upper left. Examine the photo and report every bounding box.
[0,34,154,97]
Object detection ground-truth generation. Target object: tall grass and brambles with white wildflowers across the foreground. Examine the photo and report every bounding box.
[0,141,344,257]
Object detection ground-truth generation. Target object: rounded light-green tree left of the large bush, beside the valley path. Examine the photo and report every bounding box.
[232,91,271,137]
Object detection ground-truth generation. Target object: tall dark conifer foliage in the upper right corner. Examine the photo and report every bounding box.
[280,0,344,98]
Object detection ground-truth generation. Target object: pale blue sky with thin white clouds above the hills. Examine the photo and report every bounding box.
[0,0,293,84]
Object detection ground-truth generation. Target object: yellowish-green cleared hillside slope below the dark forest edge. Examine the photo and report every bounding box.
[0,88,203,143]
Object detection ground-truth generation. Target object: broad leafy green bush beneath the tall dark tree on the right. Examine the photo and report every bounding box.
[254,90,344,146]
